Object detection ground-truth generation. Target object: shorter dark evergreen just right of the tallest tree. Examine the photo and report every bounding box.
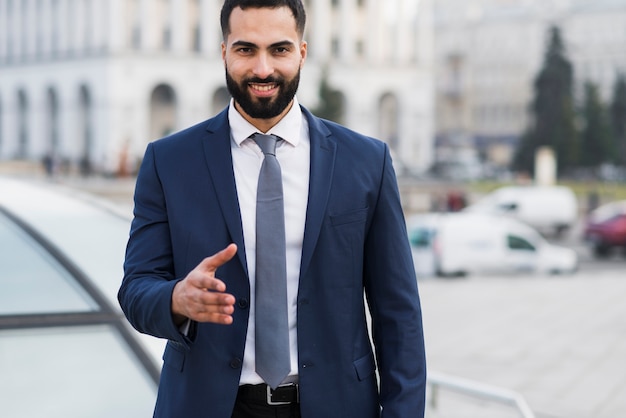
[579,82,615,168]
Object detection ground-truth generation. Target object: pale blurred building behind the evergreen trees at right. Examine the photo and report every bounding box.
[435,0,626,177]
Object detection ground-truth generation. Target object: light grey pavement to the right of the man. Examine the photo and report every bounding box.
[419,269,626,418]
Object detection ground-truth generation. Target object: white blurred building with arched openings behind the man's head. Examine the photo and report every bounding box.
[0,0,434,173]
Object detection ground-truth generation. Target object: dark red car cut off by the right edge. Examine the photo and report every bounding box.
[583,200,626,257]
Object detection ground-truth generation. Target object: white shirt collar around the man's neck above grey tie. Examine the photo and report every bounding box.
[228,96,302,147]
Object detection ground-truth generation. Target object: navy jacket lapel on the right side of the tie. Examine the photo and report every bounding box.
[300,108,337,277]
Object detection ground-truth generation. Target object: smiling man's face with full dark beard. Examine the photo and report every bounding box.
[222,7,307,126]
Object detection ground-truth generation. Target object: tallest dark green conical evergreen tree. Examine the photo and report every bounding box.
[513,26,578,174]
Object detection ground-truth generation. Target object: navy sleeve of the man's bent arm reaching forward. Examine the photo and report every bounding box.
[118,144,193,345]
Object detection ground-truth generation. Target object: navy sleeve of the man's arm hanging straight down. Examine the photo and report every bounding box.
[364,146,426,418]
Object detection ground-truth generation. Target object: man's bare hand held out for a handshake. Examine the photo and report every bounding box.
[172,244,237,325]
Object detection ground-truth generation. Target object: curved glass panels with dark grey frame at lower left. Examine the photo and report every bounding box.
[0,201,158,418]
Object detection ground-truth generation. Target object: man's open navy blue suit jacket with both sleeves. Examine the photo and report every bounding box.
[119,108,426,418]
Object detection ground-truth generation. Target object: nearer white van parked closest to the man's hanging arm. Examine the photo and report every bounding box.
[408,212,578,276]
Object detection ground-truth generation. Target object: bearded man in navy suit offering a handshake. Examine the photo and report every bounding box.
[119,0,426,418]
